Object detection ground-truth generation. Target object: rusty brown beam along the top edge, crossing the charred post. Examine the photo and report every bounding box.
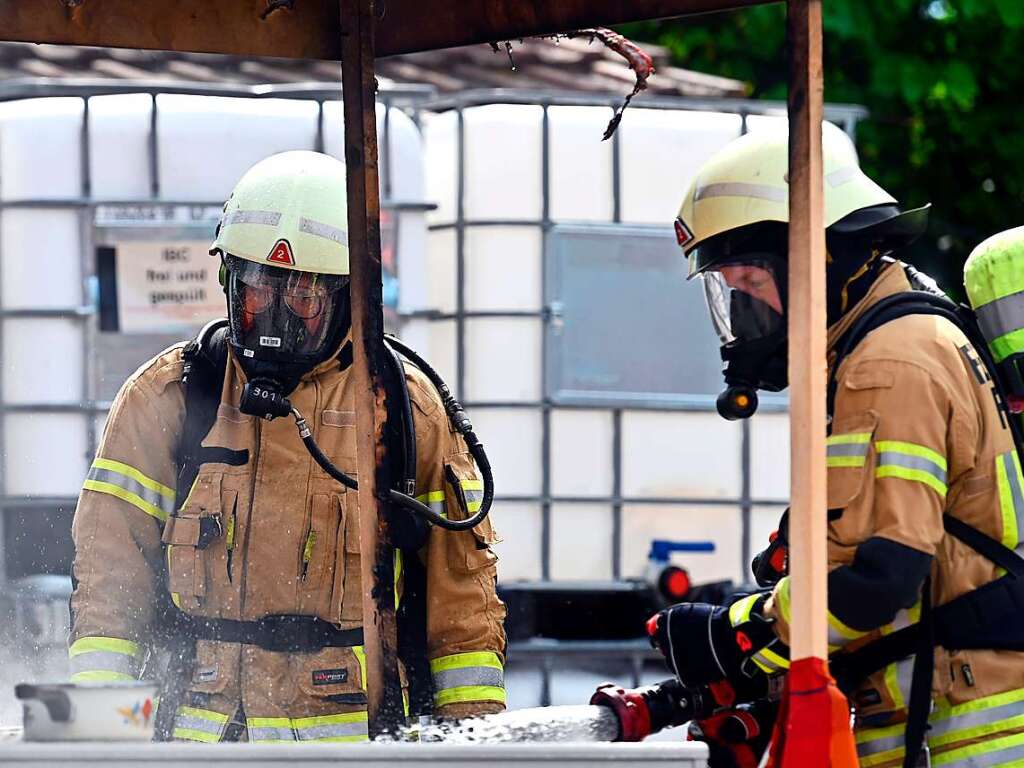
[0,0,775,60]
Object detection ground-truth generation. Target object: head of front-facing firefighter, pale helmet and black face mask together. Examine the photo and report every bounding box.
[210,152,350,392]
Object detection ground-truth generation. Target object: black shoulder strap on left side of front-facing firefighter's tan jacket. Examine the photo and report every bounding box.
[175,318,227,506]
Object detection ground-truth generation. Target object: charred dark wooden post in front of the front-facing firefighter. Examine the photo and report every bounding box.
[340,0,403,738]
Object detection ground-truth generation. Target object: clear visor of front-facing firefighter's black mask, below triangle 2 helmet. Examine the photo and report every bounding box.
[226,256,348,362]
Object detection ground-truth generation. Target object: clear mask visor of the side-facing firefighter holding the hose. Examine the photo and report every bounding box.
[700,258,785,346]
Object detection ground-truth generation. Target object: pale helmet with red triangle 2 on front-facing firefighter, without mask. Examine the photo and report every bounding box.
[210,151,348,274]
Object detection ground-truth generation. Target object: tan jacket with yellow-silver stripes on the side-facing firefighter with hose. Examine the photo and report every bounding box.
[767,263,1024,767]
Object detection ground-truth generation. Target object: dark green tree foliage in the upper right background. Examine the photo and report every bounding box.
[622,0,1024,296]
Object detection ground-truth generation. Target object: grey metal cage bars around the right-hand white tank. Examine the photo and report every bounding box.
[399,89,867,706]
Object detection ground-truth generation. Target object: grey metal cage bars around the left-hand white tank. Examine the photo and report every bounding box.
[0,78,434,590]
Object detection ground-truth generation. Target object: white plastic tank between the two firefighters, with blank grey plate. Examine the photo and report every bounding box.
[415,104,761,581]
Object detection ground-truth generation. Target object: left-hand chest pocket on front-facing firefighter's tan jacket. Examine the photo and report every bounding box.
[162,475,238,611]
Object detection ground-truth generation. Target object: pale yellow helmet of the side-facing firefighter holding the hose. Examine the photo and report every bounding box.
[676,122,928,276]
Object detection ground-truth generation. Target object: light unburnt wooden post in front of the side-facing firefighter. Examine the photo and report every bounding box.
[786,0,828,659]
